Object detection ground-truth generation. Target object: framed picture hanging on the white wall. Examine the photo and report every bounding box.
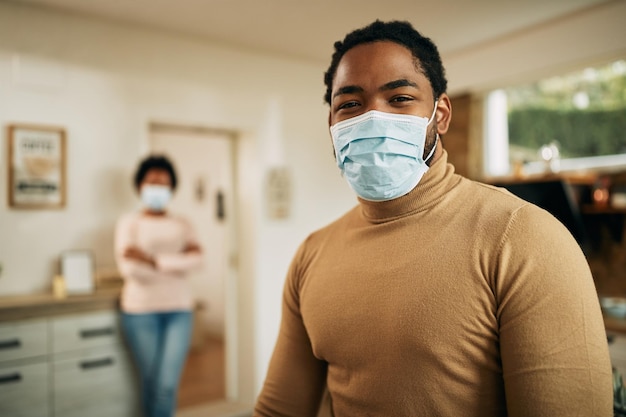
[7,124,67,209]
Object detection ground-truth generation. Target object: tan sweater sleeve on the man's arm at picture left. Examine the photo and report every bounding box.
[253,242,327,417]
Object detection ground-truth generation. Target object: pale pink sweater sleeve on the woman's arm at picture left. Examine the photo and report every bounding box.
[114,215,162,284]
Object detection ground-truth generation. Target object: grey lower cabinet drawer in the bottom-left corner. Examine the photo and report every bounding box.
[0,363,49,417]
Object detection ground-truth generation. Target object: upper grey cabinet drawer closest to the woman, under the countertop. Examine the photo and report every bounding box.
[51,311,120,353]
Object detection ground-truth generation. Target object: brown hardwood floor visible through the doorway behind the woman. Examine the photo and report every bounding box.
[178,339,226,410]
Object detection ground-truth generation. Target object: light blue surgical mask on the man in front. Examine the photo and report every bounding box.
[330,102,439,201]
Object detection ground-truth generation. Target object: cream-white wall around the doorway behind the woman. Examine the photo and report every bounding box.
[0,3,355,399]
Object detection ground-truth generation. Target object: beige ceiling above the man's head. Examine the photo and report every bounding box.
[6,0,615,63]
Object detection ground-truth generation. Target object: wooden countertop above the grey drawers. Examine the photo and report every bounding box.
[0,288,120,323]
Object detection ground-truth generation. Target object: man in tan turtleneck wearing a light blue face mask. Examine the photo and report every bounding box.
[255,21,612,417]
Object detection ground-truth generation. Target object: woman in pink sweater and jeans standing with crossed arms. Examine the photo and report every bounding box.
[115,156,202,417]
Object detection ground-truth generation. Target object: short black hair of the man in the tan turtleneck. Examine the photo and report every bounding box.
[324,20,448,104]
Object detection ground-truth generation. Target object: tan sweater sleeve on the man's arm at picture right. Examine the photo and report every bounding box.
[494,205,613,417]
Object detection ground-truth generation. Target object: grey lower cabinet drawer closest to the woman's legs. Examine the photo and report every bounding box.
[52,346,138,417]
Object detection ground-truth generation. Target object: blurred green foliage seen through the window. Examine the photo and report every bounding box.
[506,61,626,158]
